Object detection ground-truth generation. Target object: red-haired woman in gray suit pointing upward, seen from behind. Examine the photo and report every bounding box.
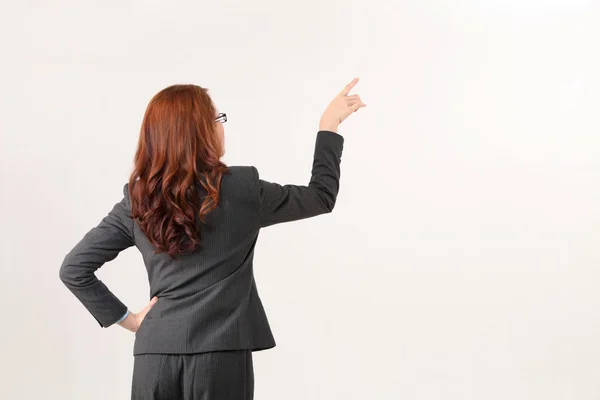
[60,78,365,400]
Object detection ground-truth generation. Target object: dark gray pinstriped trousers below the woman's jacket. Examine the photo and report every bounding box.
[131,350,254,400]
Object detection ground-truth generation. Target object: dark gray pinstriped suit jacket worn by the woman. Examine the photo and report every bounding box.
[60,131,344,355]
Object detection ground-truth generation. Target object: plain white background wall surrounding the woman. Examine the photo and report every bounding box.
[0,0,600,400]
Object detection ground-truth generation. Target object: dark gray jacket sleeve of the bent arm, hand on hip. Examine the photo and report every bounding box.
[59,184,135,328]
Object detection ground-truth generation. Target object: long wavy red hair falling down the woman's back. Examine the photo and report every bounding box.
[129,85,229,257]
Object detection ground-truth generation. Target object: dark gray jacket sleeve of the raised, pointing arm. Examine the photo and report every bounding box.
[253,131,344,227]
